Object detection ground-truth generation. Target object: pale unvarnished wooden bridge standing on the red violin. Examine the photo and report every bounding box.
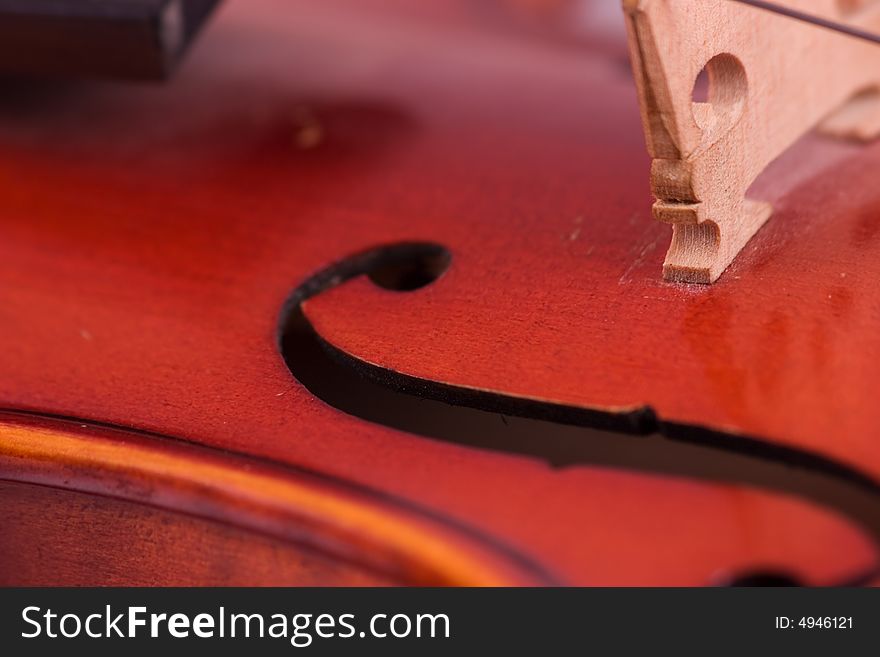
[623,0,880,283]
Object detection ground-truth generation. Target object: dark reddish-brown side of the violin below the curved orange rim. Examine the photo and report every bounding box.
[0,481,396,586]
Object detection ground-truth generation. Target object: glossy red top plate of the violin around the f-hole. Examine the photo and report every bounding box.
[0,0,880,585]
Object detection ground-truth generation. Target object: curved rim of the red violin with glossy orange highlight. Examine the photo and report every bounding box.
[0,412,556,586]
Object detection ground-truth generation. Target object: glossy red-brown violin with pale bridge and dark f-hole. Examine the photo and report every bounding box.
[0,0,880,586]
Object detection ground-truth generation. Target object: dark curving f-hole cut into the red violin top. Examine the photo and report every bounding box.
[278,242,880,585]
